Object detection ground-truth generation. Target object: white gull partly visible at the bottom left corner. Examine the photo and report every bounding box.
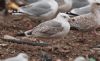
[0,53,29,61]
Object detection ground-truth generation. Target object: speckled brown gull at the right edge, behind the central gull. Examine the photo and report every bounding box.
[69,3,100,35]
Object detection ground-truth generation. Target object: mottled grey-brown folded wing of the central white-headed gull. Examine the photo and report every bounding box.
[34,21,63,35]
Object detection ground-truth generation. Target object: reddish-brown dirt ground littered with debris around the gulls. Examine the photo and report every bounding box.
[0,15,100,61]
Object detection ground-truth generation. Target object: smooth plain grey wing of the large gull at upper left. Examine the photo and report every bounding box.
[21,2,51,16]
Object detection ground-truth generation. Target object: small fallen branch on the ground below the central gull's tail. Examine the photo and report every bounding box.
[1,35,49,46]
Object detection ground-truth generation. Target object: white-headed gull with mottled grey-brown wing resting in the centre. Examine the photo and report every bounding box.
[17,13,70,38]
